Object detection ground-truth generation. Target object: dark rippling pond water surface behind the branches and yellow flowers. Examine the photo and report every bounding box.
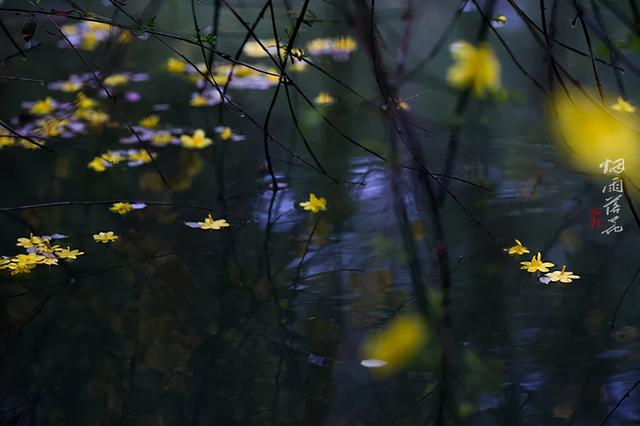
[0,0,640,426]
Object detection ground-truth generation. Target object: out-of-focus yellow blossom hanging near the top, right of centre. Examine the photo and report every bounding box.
[447,41,500,96]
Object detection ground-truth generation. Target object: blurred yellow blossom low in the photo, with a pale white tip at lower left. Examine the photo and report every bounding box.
[361,314,429,374]
